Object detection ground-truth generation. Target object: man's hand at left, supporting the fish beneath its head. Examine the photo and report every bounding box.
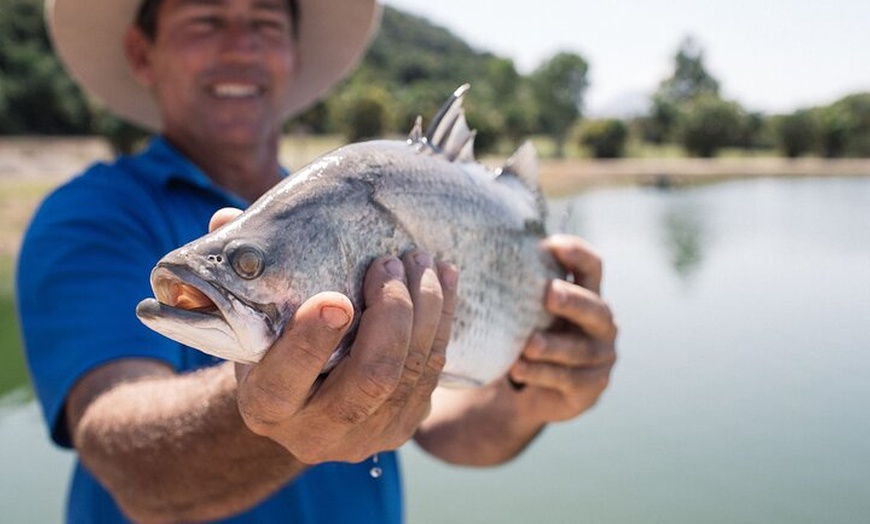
[210,210,457,464]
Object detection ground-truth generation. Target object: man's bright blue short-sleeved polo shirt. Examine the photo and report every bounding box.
[16,137,402,524]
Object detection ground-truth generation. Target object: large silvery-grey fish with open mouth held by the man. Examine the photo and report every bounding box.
[136,84,564,387]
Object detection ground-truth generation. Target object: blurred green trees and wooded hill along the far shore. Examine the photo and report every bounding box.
[0,0,870,157]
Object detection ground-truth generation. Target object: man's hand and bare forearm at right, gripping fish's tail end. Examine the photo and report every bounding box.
[415,235,616,466]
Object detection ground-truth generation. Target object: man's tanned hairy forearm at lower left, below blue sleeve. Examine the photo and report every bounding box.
[68,361,305,522]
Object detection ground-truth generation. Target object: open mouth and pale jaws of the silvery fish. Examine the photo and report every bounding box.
[136,264,280,363]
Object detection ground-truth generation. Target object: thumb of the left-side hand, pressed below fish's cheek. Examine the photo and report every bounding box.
[239,292,353,429]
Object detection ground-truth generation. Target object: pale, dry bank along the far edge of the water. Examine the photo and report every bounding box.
[0,136,870,256]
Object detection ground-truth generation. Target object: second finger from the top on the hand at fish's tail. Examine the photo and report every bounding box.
[545,280,616,342]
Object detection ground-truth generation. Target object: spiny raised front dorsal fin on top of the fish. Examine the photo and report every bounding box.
[422,84,476,162]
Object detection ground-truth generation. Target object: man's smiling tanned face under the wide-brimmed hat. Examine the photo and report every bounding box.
[128,0,296,146]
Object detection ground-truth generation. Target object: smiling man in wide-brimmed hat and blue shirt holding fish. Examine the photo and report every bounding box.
[17,0,616,523]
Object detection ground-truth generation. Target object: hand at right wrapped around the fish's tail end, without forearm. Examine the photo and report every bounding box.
[509,235,617,423]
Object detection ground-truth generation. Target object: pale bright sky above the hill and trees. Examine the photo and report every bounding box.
[383,0,870,114]
